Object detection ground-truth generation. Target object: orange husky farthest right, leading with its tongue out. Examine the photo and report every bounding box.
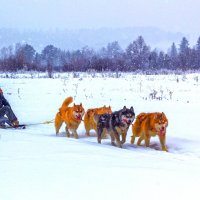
[131,112,168,151]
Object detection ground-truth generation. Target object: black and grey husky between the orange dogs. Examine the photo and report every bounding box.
[94,106,135,148]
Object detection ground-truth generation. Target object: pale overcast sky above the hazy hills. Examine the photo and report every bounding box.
[0,0,200,35]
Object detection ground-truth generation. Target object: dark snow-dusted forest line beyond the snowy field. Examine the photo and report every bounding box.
[0,36,200,72]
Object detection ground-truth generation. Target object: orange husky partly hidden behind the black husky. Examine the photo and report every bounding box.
[84,106,112,136]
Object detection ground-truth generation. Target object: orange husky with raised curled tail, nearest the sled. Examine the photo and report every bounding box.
[54,97,85,139]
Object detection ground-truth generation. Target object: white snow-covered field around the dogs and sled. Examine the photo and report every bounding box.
[0,74,200,200]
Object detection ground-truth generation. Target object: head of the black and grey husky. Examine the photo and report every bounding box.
[121,106,135,125]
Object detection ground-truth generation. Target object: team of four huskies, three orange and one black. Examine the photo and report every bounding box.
[54,97,168,151]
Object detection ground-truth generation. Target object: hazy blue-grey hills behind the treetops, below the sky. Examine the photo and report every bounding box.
[0,27,184,52]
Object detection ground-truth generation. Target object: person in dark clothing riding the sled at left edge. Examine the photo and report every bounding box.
[0,88,19,128]
